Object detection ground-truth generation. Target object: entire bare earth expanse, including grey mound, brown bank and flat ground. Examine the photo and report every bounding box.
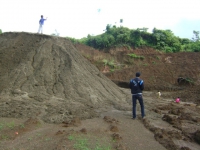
[0,32,200,150]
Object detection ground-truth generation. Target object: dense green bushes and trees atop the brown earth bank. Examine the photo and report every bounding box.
[69,25,200,52]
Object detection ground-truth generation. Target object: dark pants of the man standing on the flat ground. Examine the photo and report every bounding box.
[132,94,145,118]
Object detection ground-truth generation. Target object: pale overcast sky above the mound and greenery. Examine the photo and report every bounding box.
[0,0,200,39]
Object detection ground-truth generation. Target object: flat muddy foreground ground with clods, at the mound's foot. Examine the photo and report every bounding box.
[0,89,200,150]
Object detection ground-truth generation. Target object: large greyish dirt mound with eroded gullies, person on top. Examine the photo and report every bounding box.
[0,33,126,123]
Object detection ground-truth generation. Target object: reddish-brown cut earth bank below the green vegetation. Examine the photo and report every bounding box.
[75,44,200,103]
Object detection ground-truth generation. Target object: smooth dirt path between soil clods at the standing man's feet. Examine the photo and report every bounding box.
[100,110,165,150]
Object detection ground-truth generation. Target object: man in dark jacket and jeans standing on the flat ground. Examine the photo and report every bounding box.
[130,72,145,119]
